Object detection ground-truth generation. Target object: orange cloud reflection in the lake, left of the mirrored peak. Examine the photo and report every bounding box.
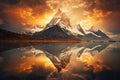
[4,55,56,73]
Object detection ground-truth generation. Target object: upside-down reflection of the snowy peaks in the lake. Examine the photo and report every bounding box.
[33,43,109,71]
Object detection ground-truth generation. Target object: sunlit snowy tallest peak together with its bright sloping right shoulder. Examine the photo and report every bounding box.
[45,9,84,36]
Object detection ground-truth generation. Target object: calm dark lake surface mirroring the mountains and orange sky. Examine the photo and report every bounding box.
[0,42,120,80]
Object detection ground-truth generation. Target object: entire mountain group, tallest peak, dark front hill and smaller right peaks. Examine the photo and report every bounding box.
[33,9,110,40]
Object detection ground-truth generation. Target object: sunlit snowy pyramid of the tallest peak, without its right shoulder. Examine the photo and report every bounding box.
[45,9,74,35]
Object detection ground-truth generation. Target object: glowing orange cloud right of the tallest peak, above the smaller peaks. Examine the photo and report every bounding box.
[80,9,112,30]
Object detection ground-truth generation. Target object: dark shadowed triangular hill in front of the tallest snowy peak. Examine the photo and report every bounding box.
[33,25,72,38]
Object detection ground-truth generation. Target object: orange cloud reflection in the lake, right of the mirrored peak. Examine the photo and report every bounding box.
[78,53,111,72]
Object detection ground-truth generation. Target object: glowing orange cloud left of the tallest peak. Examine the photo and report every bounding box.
[4,7,53,28]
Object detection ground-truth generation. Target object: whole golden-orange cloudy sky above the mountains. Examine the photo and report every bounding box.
[0,0,120,32]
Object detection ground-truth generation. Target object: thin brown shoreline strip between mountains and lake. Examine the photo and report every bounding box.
[0,39,113,43]
